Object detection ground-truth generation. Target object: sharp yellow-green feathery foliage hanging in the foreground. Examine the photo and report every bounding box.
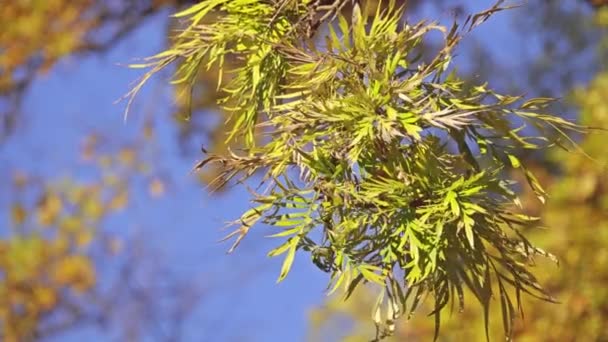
[127,0,586,339]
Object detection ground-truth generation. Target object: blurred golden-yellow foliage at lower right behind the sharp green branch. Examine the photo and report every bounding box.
[310,69,608,341]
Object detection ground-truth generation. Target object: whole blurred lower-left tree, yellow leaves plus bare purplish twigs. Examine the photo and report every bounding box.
[0,130,208,342]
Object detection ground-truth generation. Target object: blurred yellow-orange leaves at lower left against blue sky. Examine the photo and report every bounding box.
[0,129,172,341]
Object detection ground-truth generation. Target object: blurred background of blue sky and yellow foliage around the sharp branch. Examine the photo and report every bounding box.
[0,0,608,341]
